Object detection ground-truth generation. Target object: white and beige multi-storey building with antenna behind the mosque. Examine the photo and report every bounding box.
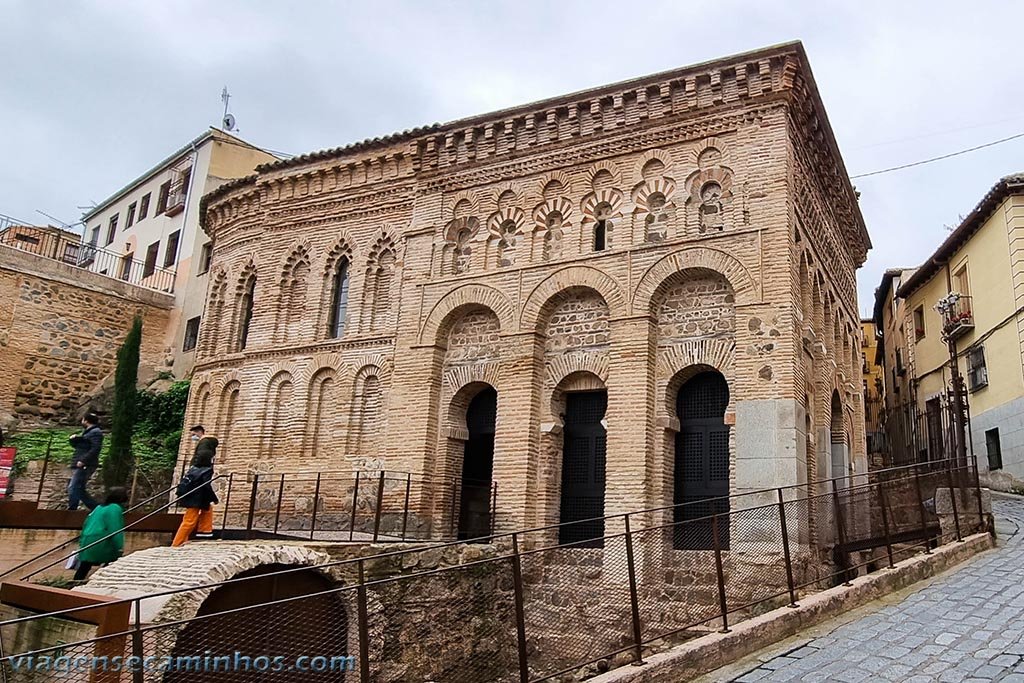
[80,128,276,377]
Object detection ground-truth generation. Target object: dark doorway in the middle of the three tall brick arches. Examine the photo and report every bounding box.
[558,390,608,548]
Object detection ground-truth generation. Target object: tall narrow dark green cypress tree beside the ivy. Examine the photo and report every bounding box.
[103,315,142,487]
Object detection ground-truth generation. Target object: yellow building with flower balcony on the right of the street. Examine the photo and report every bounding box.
[896,174,1024,487]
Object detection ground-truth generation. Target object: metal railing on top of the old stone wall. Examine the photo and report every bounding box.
[0,226,176,293]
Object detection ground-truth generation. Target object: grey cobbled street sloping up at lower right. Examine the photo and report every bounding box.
[700,496,1024,683]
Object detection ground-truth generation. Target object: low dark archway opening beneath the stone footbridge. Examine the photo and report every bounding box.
[164,564,348,683]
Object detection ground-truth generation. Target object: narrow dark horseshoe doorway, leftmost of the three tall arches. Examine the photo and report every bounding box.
[459,387,498,540]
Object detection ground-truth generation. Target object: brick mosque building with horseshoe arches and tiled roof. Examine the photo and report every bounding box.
[183,43,870,531]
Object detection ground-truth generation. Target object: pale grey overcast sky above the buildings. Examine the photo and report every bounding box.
[0,0,1024,312]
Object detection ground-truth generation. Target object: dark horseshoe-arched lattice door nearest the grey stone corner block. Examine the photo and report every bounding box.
[673,370,730,550]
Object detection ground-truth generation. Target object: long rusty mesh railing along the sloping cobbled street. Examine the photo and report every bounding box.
[0,462,985,683]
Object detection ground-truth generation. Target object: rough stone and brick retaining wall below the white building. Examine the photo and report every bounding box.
[0,245,172,422]
